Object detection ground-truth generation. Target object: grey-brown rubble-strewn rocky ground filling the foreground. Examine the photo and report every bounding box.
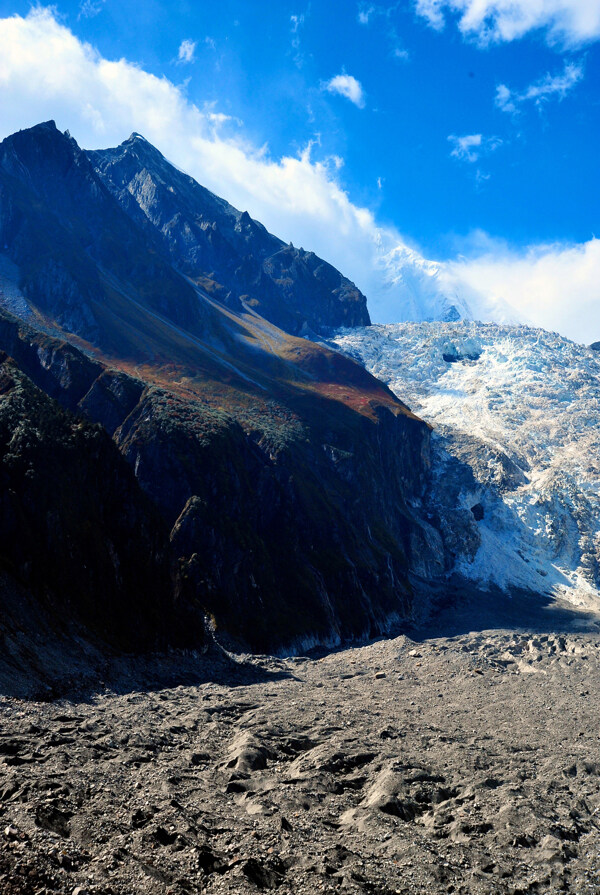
[0,597,600,895]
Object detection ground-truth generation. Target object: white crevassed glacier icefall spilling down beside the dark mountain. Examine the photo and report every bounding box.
[333,320,600,608]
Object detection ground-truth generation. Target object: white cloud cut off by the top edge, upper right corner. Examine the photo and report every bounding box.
[416,0,600,46]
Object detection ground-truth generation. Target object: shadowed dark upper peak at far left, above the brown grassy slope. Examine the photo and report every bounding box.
[0,121,202,350]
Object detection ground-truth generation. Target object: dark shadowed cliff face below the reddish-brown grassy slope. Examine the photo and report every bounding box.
[0,304,438,650]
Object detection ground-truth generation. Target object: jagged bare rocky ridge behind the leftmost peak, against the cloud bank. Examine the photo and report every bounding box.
[87,134,370,334]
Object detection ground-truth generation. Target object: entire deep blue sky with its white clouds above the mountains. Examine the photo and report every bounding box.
[0,0,600,339]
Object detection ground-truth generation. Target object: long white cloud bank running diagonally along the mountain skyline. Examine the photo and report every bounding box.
[0,8,600,341]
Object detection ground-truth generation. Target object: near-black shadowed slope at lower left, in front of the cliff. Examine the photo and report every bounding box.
[0,353,197,659]
